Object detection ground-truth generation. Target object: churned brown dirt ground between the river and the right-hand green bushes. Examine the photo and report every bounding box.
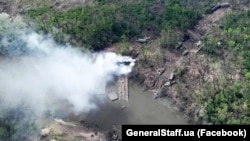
[125,1,238,124]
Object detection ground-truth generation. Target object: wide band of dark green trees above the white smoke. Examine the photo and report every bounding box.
[24,0,200,50]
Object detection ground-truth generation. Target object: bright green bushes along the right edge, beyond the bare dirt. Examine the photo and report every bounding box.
[203,11,250,124]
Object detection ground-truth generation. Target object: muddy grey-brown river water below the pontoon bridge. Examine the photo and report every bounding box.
[76,82,188,130]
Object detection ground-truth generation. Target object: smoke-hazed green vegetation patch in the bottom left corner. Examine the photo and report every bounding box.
[0,105,38,140]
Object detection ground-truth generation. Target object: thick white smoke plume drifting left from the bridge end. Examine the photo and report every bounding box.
[0,12,135,115]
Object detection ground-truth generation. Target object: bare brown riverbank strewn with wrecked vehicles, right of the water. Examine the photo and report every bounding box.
[125,3,232,124]
